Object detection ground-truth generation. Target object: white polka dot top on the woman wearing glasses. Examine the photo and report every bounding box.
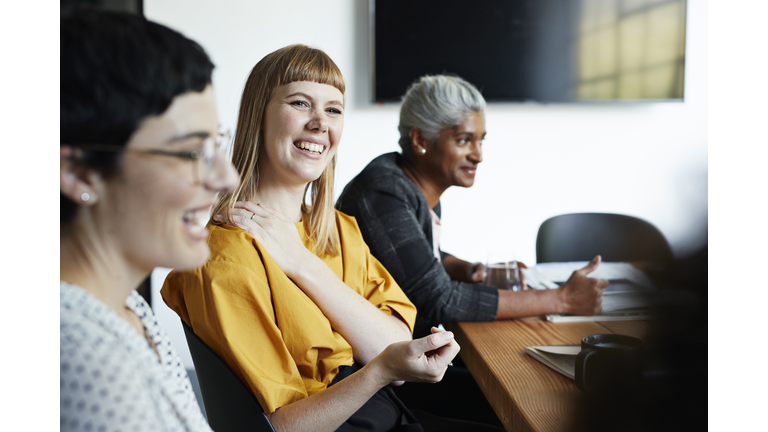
[60,281,211,432]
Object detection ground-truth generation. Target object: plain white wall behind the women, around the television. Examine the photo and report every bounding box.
[144,0,708,365]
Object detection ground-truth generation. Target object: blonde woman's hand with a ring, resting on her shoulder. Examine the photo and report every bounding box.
[224,201,316,277]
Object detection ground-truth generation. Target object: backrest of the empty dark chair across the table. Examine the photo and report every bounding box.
[536,213,672,263]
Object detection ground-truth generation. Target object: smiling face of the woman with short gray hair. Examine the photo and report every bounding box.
[426,112,486,188]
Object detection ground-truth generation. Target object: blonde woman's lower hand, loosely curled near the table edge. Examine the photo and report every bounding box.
[371,327,461,385]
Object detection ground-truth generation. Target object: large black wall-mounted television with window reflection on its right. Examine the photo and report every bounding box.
[370,0,686,103]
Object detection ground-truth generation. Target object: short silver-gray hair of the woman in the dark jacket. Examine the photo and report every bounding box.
[398,75,485,154]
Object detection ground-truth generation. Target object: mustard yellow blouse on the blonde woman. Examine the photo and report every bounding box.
[161,211,416,413]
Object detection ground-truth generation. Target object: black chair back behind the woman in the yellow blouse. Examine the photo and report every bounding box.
[181,321,275,432]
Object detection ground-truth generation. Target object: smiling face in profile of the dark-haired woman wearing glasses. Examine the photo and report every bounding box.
[93,85,238,269]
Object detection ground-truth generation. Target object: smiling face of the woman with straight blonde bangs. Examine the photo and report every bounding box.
[258,81,344,186]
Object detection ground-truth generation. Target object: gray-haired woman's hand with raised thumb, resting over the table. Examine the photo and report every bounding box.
[558,255,608,315]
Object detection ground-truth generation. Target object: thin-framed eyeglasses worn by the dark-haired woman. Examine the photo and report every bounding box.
[77,131,232,184]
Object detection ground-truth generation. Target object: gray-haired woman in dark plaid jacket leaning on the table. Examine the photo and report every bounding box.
[336,75,608,337]
